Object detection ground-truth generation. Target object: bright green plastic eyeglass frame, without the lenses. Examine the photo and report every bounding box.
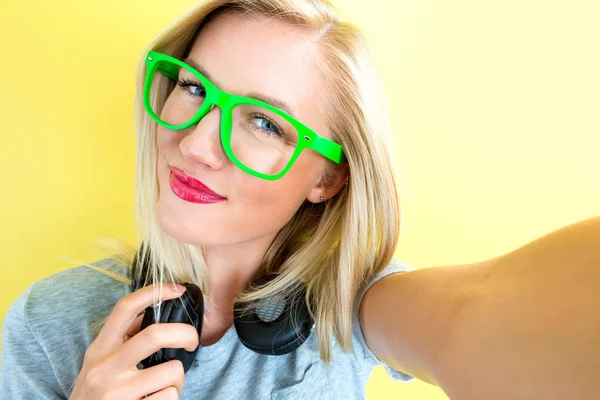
[144,51,346,180]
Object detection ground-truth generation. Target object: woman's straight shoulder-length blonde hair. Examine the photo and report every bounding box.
[83,0,400,363]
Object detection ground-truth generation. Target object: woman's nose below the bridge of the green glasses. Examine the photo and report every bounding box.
[179,105,227,170]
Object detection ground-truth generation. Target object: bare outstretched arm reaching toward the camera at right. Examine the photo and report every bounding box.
[359,217,600,400]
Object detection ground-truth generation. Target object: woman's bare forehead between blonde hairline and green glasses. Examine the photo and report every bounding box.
[188,13,330,137]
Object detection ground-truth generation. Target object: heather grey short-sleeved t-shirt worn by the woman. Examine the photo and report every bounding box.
[0,258,414,400]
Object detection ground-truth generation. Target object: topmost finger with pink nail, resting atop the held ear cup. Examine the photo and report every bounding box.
[95,283,185,352]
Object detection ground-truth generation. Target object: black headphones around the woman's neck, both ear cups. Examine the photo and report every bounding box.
[131,244,313,372]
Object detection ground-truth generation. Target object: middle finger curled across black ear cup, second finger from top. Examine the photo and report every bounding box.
[113,322,200,368]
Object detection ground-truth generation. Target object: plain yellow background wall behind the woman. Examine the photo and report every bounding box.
[0,0,600,400]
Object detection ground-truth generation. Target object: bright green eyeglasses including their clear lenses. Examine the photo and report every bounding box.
[144,51,345,180]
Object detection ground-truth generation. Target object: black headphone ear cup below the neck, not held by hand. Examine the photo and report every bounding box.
[234,279,314,355]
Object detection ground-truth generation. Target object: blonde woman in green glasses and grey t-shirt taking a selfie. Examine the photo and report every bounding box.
[1,0,599,399]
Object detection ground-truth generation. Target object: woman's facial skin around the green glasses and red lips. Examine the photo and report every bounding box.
[157,14,335,246]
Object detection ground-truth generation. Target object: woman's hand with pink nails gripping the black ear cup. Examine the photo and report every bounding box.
[70,283,199,400]
